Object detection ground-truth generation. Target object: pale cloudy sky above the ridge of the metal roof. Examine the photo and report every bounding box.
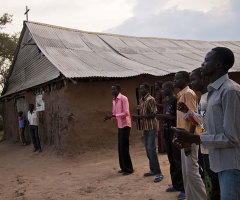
[0,0,240,41]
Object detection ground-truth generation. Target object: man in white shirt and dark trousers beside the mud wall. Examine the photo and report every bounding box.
[28,104,42,152]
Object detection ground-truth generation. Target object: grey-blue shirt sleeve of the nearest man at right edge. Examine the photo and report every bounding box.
[201,90,240,148]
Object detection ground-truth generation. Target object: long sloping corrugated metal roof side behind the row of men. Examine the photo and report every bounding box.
[26,22,240,78]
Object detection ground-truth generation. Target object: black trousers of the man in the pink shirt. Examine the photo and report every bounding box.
[118,126,133,173]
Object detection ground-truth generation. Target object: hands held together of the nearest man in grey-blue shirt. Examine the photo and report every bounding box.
[171,128,201,149]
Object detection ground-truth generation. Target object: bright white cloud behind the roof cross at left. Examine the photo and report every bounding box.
[0,0,136,32]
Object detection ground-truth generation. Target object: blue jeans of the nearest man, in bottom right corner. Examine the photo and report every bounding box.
[218,169,240,200]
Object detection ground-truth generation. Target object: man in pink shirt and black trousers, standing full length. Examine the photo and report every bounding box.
[104,84,133,175]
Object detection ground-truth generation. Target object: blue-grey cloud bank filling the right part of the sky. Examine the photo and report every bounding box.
[105,0,240,40]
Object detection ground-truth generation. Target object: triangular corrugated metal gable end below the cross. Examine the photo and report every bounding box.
[2,25,60,97]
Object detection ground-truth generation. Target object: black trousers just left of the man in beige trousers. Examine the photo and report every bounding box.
[164,127,184,191]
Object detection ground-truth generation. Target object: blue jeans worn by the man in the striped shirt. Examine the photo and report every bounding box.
[143,130,162,175]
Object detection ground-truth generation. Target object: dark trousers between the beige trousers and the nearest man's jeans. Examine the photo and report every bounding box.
[202,154,220,200]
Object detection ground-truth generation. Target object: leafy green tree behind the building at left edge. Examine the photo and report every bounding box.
[0,13,19,90]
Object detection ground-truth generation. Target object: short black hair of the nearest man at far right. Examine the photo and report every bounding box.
[212,47,235,72]
